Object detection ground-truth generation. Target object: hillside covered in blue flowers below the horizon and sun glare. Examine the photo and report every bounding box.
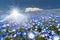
[0,10,60,40]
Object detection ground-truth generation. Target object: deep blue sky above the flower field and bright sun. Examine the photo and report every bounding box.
[0,0,60,10]
